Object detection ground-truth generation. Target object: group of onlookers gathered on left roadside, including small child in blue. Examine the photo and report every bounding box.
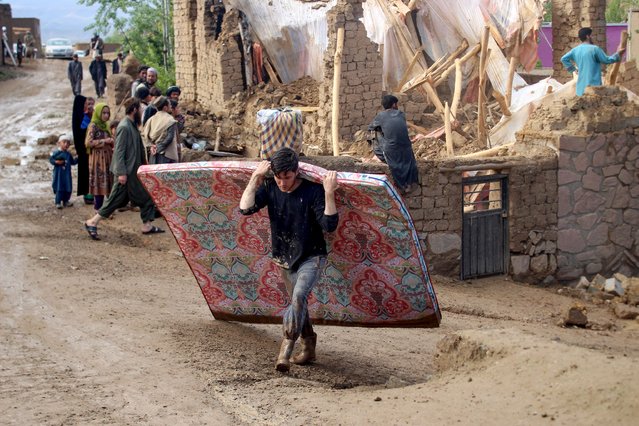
[50,51,184,240]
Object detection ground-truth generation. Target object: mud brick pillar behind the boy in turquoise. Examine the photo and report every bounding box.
[552,0,606,82]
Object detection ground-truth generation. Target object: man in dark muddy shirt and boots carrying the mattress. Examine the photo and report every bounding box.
[240,148,339,372]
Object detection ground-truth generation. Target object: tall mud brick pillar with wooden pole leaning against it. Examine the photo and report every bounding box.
[311,0,382,153]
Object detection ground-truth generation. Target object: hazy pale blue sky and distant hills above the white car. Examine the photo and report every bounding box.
[11,0,97,43]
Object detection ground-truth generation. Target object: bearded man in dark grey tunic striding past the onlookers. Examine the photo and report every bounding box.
[84,98,164,240]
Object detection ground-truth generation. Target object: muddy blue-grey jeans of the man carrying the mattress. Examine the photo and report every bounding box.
[282,256,326,340]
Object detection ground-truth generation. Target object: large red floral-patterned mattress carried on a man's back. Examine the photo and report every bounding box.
[138,161,441,327]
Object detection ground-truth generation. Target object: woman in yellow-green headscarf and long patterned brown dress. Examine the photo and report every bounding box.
[86,103,115,211]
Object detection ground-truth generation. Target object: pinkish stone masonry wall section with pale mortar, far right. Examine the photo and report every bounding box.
[557,131,639,280]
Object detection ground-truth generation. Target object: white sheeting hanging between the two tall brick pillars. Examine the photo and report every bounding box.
[225,0,336,83]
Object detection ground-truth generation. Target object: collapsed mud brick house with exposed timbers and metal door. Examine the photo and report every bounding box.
[169,0,639,283]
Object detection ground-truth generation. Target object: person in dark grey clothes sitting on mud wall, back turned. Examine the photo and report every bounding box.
[368,95,419,193]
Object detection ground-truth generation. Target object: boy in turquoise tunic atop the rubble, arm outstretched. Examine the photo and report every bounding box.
[561,27,626,96]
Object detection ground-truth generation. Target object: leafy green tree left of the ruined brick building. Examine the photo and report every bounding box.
[77,0,175,89]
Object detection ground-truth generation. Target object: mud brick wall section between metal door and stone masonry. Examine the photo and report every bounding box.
[507,157,558,283]
